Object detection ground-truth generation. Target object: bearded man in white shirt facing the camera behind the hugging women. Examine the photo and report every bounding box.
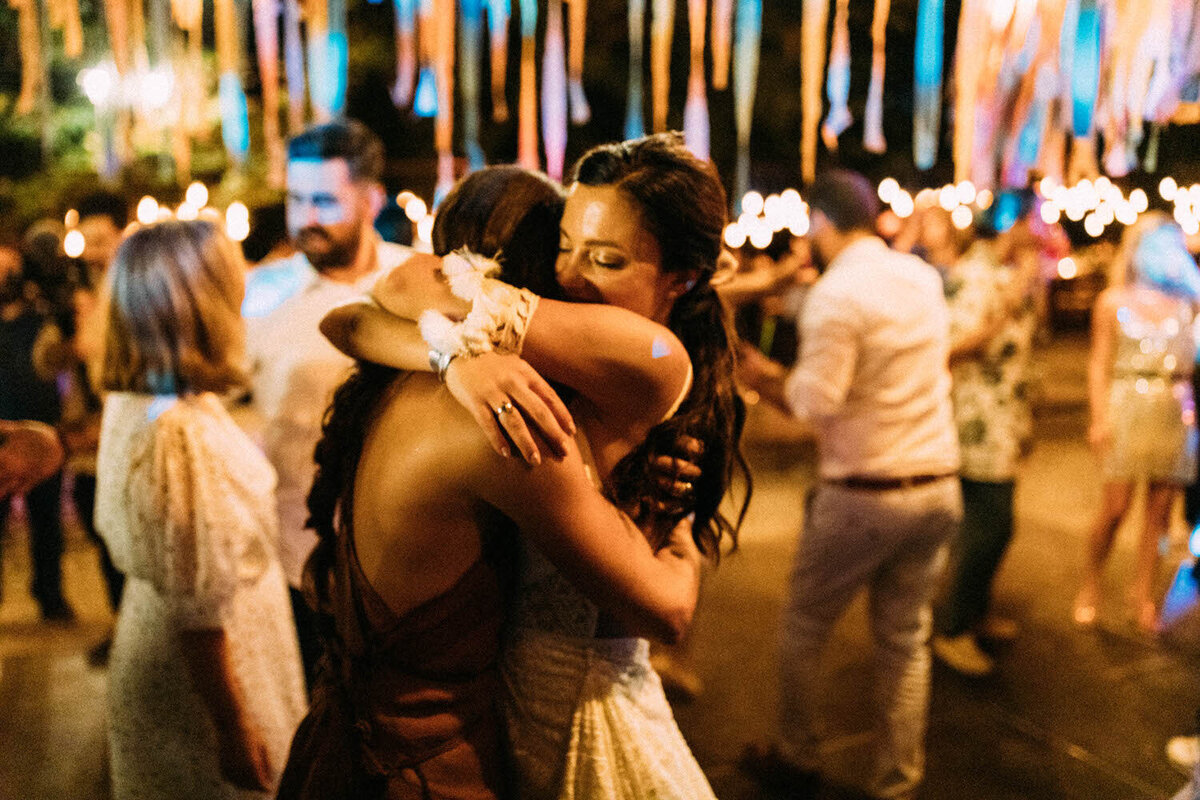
[242,120,412,682]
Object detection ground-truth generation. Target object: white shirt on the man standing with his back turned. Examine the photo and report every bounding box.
[784,236,959,480]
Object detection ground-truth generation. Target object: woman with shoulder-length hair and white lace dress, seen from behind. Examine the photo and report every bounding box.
[96,221,306,800]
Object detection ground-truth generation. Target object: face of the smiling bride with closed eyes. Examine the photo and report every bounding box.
[554,184,684,324]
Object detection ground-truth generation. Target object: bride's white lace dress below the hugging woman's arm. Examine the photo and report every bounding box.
[502,435,714,800]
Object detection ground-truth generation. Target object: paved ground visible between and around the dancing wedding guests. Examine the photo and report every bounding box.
[0,339,1200,800]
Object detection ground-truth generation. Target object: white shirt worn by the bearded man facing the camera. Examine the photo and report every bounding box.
[242,241,413,588]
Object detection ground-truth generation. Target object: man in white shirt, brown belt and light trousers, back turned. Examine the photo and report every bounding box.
[739,172,962,799]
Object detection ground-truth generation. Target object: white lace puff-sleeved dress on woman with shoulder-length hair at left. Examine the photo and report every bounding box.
[96,392,307,800]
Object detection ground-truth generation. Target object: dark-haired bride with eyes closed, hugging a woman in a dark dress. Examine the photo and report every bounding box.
[335,136,744,800]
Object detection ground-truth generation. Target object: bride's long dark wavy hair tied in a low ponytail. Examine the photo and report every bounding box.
[574,133,752,559]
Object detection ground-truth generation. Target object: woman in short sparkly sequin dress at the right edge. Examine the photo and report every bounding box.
[1074,213,1200,632]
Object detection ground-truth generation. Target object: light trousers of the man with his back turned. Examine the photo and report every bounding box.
[779,477,962,798]
